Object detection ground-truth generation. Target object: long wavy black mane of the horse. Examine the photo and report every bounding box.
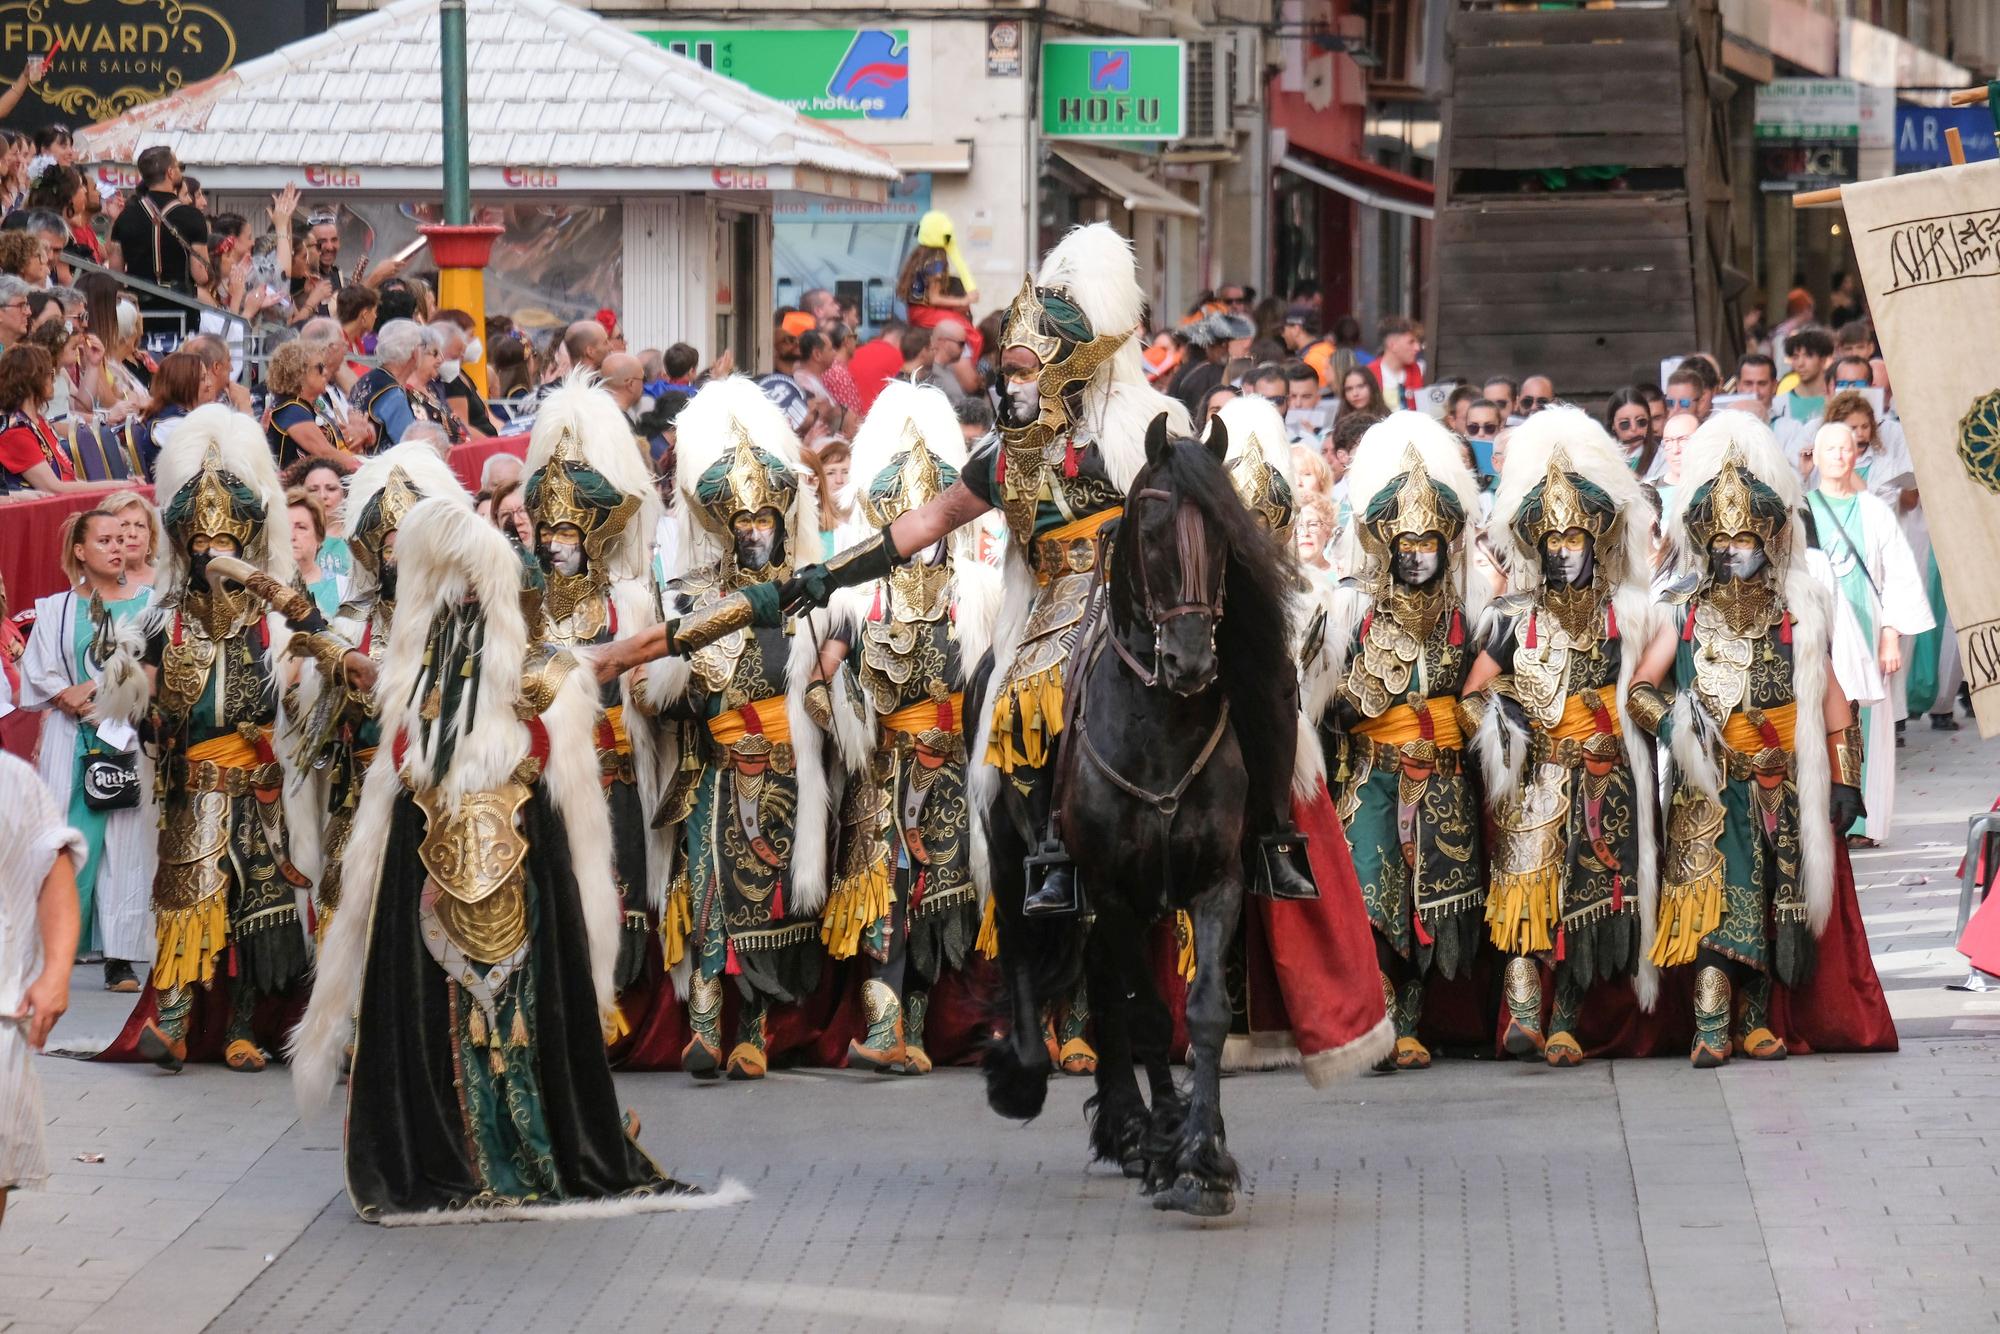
[1110,440,1298,756]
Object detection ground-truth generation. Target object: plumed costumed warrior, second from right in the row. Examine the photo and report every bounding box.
[1460,406,1660,1066]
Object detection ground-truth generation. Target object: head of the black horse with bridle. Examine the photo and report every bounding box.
[1112,412,1242,696]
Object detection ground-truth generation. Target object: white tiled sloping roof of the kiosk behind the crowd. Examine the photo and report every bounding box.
[78,0,898,198]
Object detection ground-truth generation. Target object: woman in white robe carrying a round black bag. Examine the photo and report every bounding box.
[20,510,158,992]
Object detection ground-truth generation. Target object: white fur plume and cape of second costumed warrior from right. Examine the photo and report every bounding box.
[1474,404,1660,1010]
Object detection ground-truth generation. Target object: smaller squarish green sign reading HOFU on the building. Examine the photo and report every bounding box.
[1042,38,1188,140]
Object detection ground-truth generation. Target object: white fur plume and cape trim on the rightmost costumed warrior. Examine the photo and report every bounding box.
[1666,412,1834,936]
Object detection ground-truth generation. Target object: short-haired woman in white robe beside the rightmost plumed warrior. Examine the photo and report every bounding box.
[1808,422,1934,848]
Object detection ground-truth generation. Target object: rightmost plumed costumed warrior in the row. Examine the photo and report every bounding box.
[1632,412,1862,1068]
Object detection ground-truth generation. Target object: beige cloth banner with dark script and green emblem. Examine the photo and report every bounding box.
[1840,162,2000,736]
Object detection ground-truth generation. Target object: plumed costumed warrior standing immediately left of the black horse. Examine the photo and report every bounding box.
[806,382,1000,1074]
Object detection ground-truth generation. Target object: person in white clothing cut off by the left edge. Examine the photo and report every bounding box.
[0,752,84,1218]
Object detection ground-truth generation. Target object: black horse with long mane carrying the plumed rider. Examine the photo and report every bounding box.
[986,414,1292,1216]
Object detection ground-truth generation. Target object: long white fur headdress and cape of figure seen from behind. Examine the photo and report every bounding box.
[290,498,622,1112]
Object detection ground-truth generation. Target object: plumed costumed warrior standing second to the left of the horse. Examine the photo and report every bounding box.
[636,378,832,1080]
